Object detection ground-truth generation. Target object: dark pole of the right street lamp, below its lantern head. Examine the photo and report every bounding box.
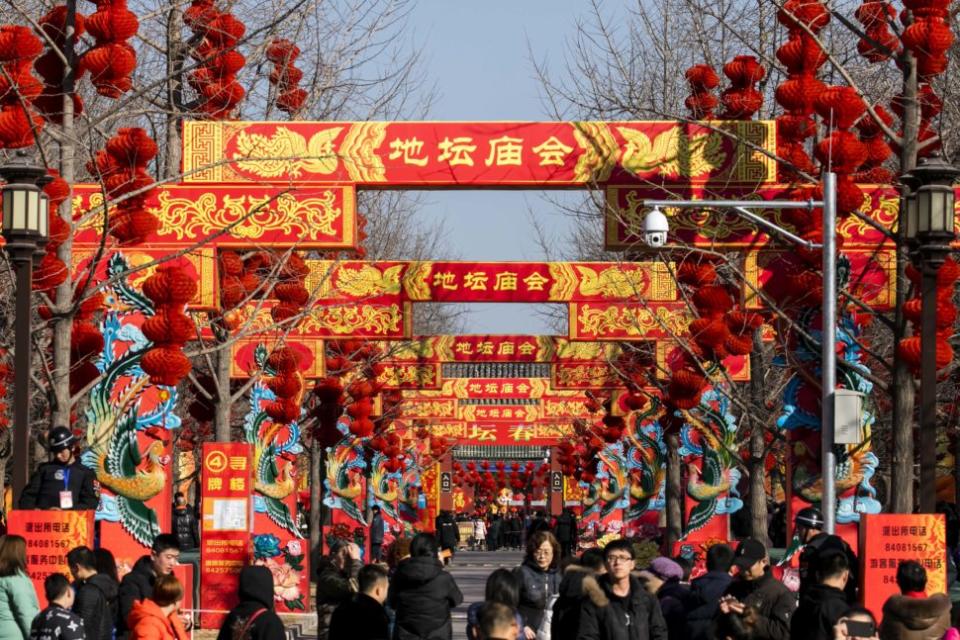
[919,260,938,513]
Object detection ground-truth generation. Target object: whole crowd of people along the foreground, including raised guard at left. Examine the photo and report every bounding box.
[0,429,960,640]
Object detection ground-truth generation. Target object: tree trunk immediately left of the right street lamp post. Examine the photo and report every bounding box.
[888,54,919,513]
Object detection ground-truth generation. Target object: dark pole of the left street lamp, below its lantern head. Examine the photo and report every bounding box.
[7,248,33,504]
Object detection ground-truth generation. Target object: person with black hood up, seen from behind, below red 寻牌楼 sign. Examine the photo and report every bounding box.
[217,566,286,640]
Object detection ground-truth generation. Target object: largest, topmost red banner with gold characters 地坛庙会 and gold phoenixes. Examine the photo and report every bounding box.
[183,121,776,188]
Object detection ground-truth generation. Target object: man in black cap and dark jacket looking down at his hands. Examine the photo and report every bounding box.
[717,538,797,640]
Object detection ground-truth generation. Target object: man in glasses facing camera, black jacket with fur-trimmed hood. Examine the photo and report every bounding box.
[577,540,667,640]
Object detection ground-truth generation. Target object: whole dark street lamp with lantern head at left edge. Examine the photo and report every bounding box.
[0,149,49,504]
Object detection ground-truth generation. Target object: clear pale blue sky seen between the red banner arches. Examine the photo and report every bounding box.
[409,0,602,334]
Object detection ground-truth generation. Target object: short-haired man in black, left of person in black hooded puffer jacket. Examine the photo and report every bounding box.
[330,564,390,640]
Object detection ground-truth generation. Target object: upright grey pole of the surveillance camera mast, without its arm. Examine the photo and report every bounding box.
[820,172,837,533]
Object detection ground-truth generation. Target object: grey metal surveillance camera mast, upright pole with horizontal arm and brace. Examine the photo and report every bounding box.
[643,172,837,533]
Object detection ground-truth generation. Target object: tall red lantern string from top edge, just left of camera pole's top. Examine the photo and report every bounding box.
[775,0,830,181]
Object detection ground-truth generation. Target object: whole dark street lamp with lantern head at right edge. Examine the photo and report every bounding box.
[904,155,960,513]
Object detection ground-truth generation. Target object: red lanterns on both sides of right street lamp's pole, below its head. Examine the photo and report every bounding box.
[897,257,960,375]
